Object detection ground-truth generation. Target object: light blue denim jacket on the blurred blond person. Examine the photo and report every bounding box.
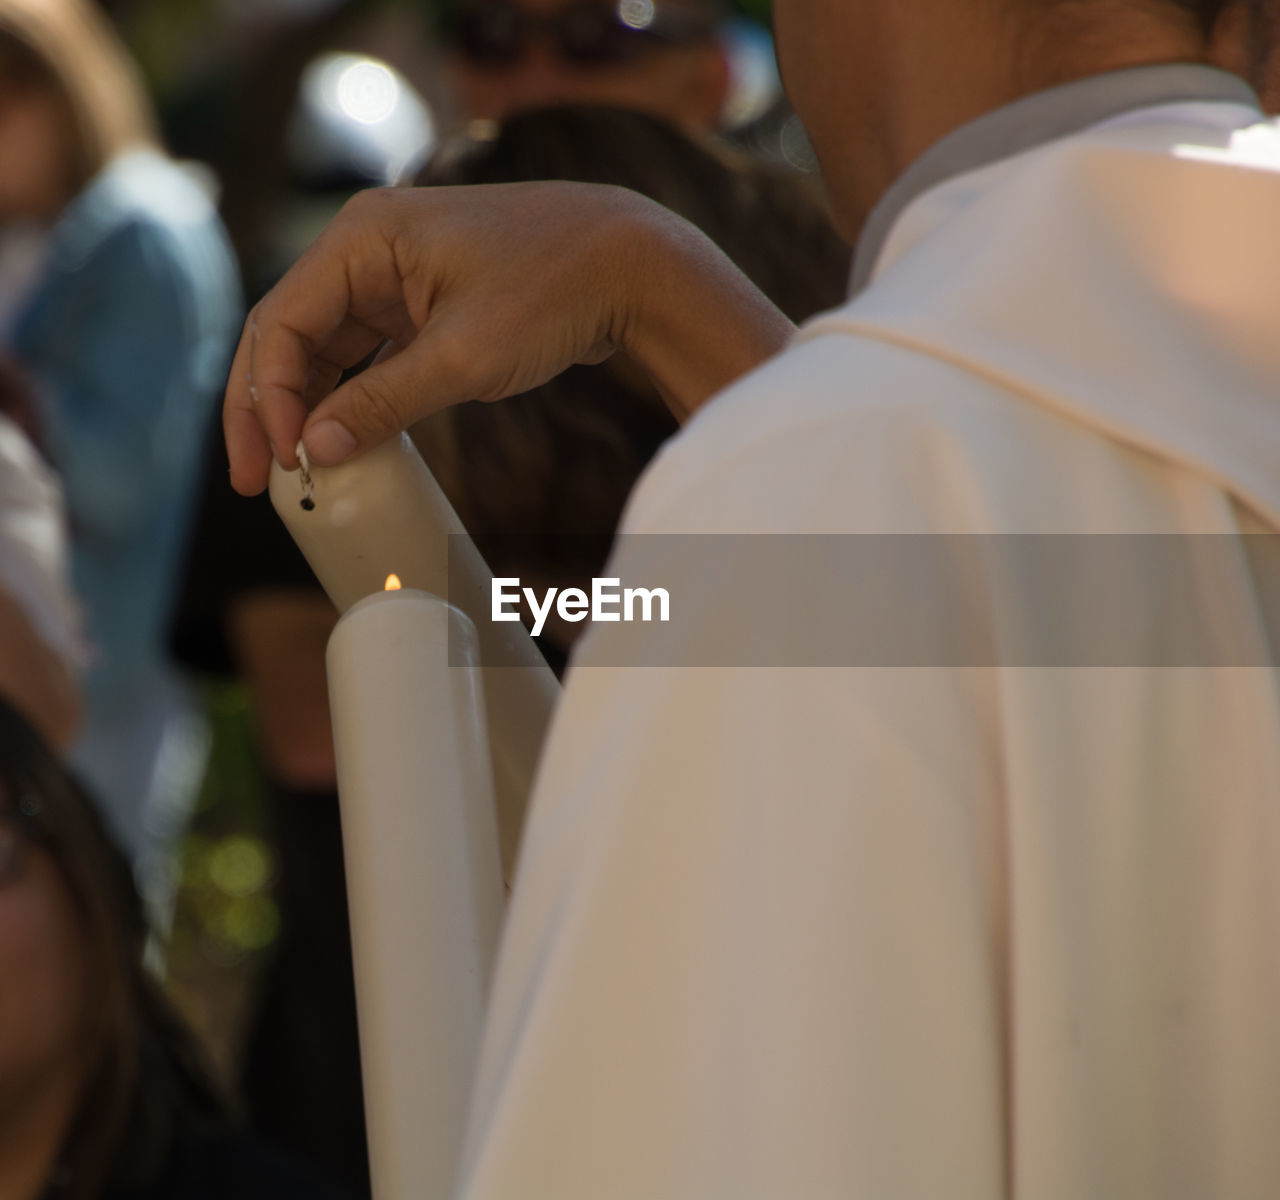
[13,151,242,709]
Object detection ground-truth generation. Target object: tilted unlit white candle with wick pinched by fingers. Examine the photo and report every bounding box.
[270,434,559,881]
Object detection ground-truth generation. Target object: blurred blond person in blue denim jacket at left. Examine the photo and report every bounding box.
[0,0,239,912]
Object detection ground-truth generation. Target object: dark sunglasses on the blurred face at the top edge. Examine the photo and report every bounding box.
[445,0,713,67]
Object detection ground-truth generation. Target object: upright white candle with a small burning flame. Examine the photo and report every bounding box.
[328,590,503,1200]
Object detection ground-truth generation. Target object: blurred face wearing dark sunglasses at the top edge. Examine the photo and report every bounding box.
[439,0,730,130]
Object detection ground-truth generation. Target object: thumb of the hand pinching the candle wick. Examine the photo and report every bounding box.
[302,343,438,467]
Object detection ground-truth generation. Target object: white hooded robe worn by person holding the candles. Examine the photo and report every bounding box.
[460,95,1280,1200]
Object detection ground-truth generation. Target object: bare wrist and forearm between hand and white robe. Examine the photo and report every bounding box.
[616,210,795,421]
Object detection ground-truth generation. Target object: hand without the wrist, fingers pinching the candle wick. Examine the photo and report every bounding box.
[224,184,655,494]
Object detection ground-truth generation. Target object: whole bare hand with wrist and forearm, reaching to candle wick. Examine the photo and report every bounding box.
[223,183,792,495]
